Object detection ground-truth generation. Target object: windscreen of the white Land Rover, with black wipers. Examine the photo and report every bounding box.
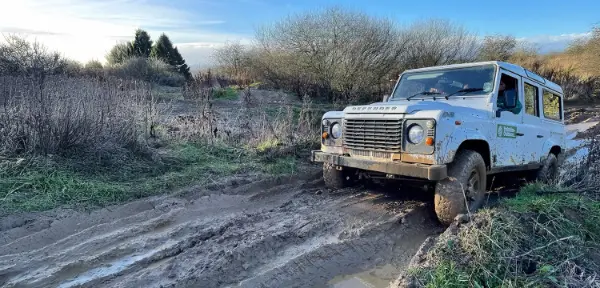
[391,65,495,100]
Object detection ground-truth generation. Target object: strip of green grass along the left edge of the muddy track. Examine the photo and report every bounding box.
[0,143,298,214]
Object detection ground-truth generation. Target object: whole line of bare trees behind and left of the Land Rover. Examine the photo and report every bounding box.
[214,8,600,102]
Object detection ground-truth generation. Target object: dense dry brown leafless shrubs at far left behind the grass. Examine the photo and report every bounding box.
[0,76,156,155]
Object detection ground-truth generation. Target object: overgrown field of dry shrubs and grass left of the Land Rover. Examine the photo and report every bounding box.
[0,77,331,214]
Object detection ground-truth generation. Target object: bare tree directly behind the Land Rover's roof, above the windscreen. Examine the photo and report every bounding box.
[402,19,480,68]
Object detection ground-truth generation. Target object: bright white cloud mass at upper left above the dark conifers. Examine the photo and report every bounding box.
[0,0,251,66]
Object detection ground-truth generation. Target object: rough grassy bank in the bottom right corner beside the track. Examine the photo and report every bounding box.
[410,185,600,287]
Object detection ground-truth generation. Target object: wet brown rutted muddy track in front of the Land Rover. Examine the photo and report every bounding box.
[0,173,440,287]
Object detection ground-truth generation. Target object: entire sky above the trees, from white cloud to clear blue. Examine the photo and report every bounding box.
[0,0,600,66]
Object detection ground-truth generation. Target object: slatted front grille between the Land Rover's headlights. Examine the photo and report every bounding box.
[343,119,402,153]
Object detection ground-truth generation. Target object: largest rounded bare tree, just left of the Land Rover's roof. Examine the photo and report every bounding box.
[255,8,405,102]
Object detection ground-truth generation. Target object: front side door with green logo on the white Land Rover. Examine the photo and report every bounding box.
[490,69,528,168]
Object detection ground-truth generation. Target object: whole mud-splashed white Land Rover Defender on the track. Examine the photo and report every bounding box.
[311,61,566,225]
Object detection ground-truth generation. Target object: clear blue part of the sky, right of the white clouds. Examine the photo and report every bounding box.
[173,0,600,37]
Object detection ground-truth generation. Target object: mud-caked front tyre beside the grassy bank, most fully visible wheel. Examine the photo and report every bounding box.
[434,150,487,226]
